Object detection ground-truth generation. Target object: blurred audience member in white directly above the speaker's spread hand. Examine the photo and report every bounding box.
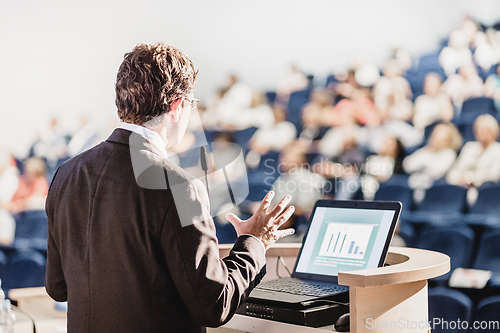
[249,104,297,155]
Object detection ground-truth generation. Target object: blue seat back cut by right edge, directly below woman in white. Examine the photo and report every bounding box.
[463,185,500,228]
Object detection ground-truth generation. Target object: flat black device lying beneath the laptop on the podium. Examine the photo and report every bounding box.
[236,301,349,327]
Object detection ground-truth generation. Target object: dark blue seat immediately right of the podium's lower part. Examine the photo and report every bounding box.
[429,287,472,333]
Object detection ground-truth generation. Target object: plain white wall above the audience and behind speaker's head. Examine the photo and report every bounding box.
[0,0,500,154]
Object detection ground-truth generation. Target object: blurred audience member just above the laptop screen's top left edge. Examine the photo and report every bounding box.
[313,136,366,200]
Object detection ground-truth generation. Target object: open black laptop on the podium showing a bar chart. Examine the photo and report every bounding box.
[247,200,401,306]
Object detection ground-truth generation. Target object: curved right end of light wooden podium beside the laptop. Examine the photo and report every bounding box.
[339,247,450,333]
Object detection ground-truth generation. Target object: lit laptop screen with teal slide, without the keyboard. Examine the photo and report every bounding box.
[295,201,400,277]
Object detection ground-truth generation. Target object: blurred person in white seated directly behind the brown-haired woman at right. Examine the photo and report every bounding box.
[413,73,453,131]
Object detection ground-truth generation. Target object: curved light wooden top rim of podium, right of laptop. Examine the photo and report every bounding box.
[338,247,450,287]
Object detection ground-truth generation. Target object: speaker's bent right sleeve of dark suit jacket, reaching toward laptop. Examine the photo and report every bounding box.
[161,180,265,327]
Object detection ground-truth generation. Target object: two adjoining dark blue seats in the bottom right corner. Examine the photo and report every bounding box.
[429,287,500,333]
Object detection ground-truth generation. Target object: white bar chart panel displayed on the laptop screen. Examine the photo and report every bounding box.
[319,222,373,259]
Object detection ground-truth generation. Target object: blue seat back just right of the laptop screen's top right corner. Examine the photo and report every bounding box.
[406,185,467,225]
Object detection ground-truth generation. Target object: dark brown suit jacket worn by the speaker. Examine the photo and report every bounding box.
[45,129,265,333]
